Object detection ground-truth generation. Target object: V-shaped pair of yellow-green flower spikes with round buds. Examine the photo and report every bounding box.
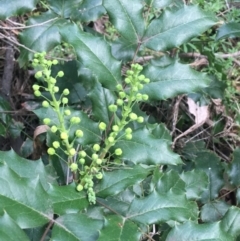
[32,53,150,204]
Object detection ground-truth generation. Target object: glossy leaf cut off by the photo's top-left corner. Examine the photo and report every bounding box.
[0,0,38,20]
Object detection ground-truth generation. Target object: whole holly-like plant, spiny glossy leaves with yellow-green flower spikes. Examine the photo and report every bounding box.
[0,0,240,241]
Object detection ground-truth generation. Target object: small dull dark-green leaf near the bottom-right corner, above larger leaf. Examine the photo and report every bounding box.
[201,201,230,223]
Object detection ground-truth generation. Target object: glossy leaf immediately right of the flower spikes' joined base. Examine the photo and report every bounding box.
[95,165,149,198]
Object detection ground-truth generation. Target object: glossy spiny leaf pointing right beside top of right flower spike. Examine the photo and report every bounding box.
[142,62,210,100]
